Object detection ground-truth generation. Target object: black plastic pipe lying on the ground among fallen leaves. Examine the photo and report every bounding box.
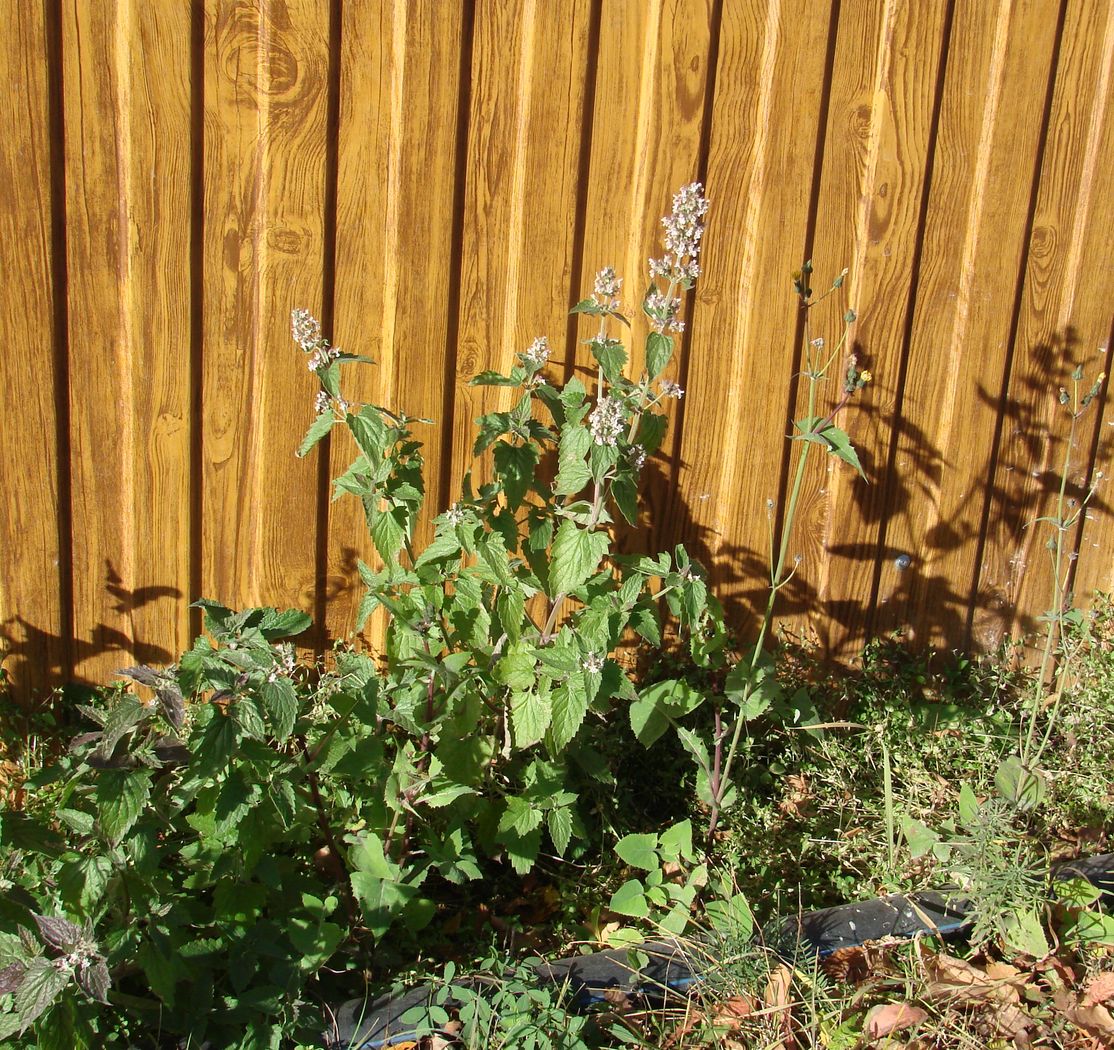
[324,853,1114,1050]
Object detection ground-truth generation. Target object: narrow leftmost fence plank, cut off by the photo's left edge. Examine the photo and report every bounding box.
[0,3,67,701]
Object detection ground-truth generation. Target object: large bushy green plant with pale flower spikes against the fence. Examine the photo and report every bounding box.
[0,192,739,1047]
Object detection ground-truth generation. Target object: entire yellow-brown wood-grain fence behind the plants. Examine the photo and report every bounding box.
[0,0,1114,708]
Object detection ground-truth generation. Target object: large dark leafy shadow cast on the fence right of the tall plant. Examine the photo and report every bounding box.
[620,327,1114,661]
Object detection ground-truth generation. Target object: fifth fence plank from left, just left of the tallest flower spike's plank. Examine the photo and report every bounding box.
[451,0,590,480]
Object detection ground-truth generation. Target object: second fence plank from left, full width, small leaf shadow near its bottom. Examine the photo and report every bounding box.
[62,0,190,683]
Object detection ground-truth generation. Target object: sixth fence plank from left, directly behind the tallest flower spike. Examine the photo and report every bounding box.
[569,0,714,550]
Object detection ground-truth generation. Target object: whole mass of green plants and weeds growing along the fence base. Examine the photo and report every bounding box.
[0,184,1114,1048]
